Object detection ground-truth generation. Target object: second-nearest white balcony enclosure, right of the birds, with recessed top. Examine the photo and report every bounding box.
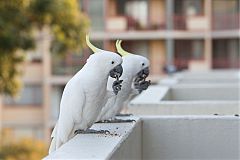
[127,84,240,115]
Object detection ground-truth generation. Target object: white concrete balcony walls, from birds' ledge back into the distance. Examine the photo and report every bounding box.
[45,70,240,160]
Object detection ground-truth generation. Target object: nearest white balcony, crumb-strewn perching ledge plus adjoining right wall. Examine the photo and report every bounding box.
[44,116,239,160]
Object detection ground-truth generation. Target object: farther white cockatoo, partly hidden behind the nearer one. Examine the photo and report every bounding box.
[97,41,150,121]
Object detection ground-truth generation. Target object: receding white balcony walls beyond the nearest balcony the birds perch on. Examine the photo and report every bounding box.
[128,71,240,115]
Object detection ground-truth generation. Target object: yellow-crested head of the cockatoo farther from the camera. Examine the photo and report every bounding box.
[116,40,150,92]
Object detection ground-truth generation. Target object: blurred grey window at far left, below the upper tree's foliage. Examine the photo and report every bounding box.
[3,84,43,105]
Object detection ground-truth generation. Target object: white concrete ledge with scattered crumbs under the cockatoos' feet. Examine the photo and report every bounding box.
[44,116,141,160]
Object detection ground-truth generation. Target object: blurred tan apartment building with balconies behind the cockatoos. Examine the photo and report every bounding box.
[0,0,240,142]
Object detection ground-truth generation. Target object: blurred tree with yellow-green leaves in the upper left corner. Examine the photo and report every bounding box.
[0,0,88,96]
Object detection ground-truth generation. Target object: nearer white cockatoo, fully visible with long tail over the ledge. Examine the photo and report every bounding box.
[49,35,123,153]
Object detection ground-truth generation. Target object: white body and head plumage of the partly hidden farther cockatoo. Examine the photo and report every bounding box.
[97,54,149,121]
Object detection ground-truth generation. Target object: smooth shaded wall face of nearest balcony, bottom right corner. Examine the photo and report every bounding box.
[142,116,240,160]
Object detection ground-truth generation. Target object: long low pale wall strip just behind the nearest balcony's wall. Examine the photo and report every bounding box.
[128,101,240,116]
